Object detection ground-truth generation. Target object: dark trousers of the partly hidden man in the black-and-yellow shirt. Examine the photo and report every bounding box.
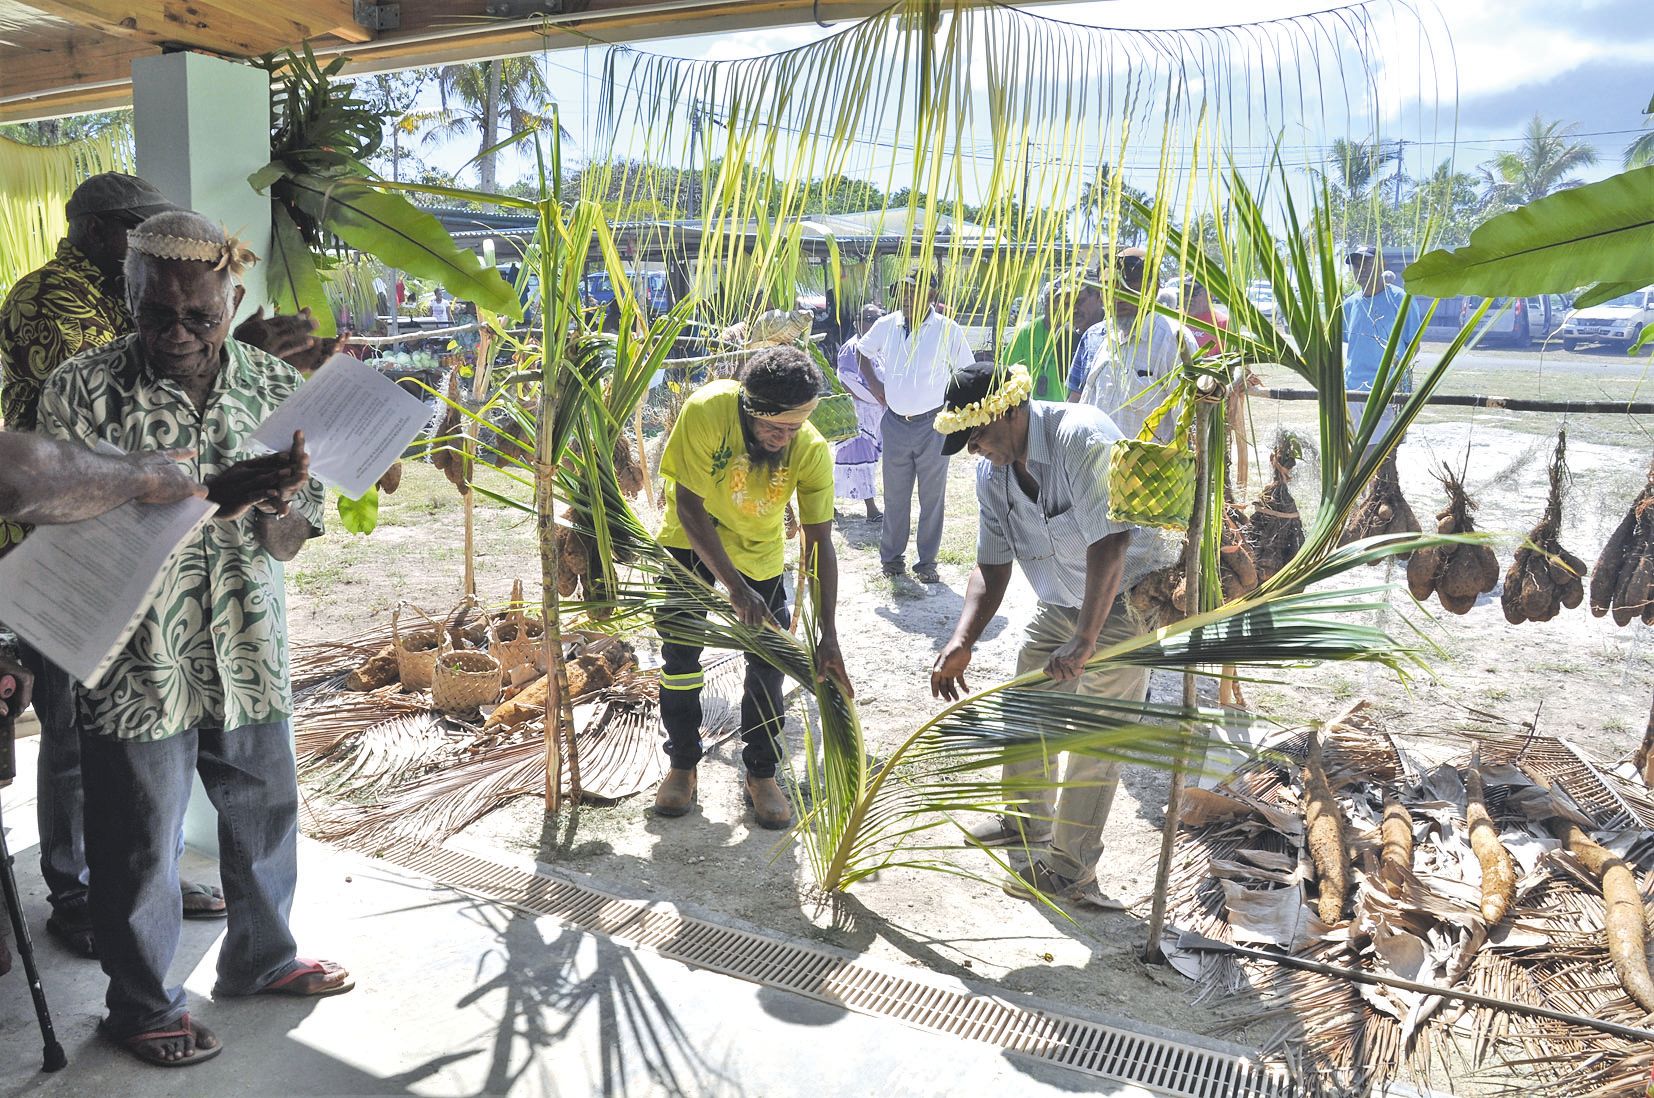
[17,643,86,908]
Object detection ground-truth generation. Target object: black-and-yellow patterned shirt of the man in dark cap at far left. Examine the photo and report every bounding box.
[0,240,132,554]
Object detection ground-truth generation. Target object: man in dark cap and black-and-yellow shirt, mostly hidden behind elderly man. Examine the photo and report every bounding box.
[0,172,321,957]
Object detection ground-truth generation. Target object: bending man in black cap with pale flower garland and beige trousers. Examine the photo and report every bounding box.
[931,364,1156,908]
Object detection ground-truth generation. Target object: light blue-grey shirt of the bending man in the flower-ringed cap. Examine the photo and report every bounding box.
[976,400,1166,607]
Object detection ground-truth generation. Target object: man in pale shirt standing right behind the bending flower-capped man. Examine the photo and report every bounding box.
[1068,248,1197,442]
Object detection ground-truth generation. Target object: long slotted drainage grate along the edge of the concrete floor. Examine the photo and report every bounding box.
[377,842,1297,1098]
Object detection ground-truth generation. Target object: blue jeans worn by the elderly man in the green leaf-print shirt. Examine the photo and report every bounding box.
[81,721,298,1038]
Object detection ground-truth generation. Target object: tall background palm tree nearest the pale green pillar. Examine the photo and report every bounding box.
[420,58,556,193]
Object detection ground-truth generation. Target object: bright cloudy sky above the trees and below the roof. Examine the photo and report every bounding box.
[416,0,1654,190]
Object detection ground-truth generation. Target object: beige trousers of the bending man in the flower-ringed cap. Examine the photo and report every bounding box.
[1006,595,1148,880]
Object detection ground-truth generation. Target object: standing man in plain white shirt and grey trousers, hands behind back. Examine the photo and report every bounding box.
[858,268,974,584]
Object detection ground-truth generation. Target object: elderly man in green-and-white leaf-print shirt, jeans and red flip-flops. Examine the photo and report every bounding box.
[40,212,352,1065]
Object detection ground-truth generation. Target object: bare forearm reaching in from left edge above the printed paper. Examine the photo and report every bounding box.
[0,432,207,526]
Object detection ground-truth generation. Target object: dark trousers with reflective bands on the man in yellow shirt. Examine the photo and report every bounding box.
[657,547,789,777]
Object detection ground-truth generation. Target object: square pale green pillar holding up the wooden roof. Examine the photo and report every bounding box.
[132,53,270,322]
